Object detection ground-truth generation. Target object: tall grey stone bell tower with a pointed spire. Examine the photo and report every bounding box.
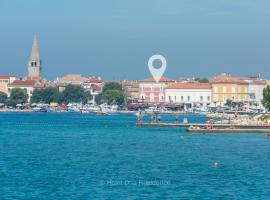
[28,36,42,79]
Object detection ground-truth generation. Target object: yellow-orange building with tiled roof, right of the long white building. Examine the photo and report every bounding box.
[211,74,249,106]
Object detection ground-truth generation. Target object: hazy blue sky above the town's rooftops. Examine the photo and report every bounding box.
[0,0,270,80]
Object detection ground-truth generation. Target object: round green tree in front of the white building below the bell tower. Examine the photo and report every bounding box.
[7,88,28,107]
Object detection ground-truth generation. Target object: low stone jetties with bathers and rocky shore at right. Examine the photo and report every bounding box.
[136,113,270,134]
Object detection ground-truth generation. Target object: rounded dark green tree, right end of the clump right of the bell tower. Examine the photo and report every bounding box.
[59,85,91,104]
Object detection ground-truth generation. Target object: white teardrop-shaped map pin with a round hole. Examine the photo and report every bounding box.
[148,55,167,82]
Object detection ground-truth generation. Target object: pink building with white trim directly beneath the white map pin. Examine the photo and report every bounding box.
[139,77,175,103]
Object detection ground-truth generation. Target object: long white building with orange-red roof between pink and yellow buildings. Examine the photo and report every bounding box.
[165,83,212,107]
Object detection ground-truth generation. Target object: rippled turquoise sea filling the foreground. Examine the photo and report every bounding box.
[0,113,270,200]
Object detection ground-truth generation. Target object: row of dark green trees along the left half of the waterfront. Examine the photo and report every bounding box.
[0,82,125,107]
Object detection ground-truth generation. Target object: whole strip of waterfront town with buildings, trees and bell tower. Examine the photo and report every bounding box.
[0,37,270,118]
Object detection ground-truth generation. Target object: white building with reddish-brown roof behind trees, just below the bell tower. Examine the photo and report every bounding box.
[8,80,45,101]
